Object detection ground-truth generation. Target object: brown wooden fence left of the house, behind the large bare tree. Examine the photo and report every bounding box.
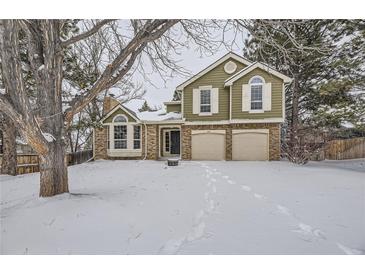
[0,149,93,174]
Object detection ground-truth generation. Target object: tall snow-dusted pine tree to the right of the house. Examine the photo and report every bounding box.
[245,20,365,163]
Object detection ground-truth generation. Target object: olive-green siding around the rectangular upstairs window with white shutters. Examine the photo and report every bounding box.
[183,58,246,121]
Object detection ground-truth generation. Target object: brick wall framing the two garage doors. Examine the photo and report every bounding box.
[181,123,280,161]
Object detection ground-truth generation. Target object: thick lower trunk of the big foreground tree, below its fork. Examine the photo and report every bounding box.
[39,141,68,197]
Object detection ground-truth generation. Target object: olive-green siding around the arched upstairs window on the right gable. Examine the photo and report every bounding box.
[232,68,283,119]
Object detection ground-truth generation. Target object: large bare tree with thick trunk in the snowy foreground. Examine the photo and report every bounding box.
[0,20,178,196]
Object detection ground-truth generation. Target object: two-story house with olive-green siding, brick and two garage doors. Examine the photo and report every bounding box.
[94,53,291,160]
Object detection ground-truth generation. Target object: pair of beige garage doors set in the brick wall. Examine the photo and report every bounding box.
[191,129,269,161]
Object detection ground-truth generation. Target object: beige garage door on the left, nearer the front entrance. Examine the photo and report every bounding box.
[191,130,226,160]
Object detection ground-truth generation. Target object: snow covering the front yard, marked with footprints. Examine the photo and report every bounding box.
[0,159,365,254]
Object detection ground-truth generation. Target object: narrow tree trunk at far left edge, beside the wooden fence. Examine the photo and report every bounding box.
[1,116,17,176]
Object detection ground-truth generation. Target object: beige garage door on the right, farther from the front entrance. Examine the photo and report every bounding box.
[232,129,269,161]
